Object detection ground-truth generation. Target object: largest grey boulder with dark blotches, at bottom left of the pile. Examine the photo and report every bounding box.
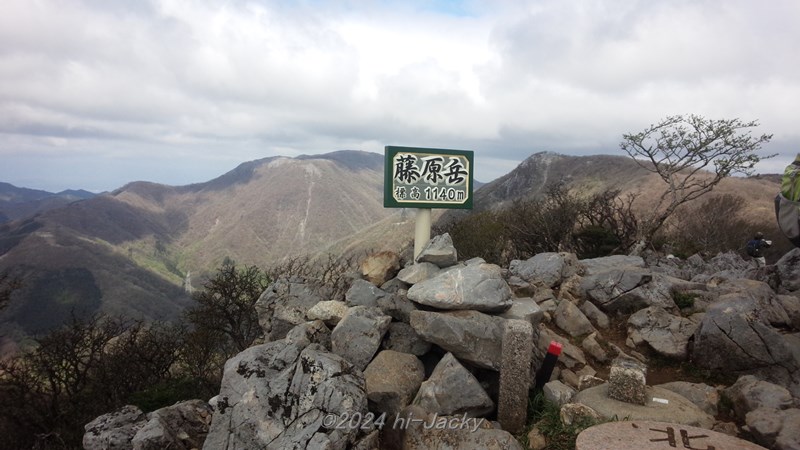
[203,340,369,450]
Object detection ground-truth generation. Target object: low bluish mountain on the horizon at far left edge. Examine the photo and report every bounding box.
[0,182,95,223]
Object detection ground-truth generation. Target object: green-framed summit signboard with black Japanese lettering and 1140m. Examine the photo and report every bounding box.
[383,146,474,209]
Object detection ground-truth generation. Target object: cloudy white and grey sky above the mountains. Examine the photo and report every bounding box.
[0,0,800,192]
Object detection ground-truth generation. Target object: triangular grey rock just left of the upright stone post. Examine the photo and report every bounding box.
[413,353,494,417]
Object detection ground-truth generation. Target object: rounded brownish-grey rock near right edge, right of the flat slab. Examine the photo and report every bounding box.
[724,375,794,417]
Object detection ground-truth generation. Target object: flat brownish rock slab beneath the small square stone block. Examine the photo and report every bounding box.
[572,383,714,429]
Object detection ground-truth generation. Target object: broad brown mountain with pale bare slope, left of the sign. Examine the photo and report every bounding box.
[0,151,394,342]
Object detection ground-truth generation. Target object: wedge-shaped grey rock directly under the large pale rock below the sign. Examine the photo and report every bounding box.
[411,311,505,370]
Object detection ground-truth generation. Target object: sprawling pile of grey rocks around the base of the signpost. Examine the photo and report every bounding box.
[87,235,800,449]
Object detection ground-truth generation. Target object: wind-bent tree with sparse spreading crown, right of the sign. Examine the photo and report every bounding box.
[620,114,774,254]
